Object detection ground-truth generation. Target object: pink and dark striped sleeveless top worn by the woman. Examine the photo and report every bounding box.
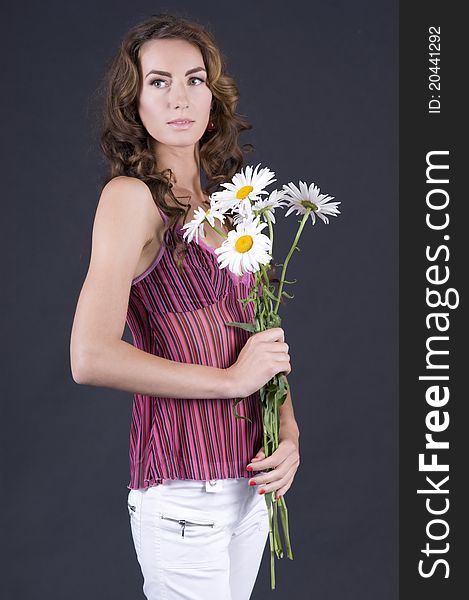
[127,205,263,489]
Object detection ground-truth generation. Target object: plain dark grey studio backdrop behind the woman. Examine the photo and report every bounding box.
[1,0,398,600]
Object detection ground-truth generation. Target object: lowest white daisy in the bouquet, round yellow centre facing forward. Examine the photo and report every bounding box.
[215,216,272,276]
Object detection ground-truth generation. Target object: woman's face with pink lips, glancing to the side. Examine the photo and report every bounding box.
[138,39,212,146]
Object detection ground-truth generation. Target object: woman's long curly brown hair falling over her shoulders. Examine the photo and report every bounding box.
[100,13,253,268]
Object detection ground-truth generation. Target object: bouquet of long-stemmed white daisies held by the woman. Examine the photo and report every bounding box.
[183,164,340,589]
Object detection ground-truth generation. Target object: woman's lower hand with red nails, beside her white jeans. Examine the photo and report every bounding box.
[248,427,300,500]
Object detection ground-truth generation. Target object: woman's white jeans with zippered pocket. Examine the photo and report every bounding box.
[128,477,269,600]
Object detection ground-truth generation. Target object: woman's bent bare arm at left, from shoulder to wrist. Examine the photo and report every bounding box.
[70,177,236,399]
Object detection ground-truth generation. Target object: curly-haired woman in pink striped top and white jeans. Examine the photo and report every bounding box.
[71,15,299,600]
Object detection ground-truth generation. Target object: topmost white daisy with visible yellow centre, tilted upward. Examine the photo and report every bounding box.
[208,163,277,217]
